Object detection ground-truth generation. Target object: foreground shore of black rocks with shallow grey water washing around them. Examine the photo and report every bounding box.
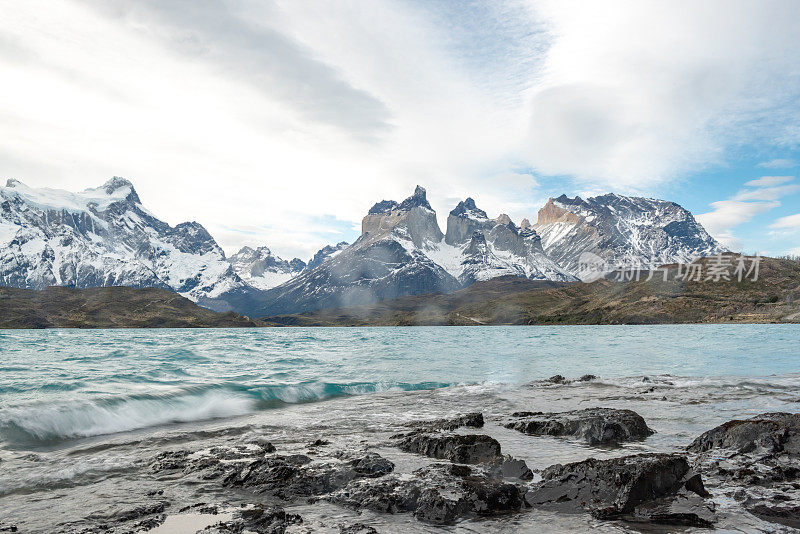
[0,375,800,534]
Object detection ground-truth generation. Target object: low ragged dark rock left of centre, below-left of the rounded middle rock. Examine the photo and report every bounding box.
[223,453,394,499]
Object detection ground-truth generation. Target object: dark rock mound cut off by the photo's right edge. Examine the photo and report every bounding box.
[688,413,800,455]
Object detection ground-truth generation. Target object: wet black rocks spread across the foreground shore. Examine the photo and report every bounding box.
[37,402,800,534]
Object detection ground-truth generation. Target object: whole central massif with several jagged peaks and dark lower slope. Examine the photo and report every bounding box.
[253,186,577,315]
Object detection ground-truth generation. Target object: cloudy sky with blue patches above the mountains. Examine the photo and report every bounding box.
[0,0,800,259]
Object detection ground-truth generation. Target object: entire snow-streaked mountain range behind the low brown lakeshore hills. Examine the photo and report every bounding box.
[0,177,725,316]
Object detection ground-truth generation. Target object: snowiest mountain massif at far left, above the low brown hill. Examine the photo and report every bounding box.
[0,177,246,308]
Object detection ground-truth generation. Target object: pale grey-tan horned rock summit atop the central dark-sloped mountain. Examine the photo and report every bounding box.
[356,186,444,247]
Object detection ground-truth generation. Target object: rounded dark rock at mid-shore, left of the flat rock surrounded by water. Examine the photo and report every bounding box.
[397,432,500,464]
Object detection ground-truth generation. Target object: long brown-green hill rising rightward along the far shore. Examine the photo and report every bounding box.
[263,255,800,326]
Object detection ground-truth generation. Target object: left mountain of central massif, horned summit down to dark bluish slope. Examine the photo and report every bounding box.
[257,187,460,315]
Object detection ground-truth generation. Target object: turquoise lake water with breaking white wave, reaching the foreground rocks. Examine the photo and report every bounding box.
[0,325,800,532]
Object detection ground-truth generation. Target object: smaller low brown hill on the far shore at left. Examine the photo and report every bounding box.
[0,287,257,328]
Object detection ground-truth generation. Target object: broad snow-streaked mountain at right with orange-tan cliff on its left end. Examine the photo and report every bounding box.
[533,193,726,274]
